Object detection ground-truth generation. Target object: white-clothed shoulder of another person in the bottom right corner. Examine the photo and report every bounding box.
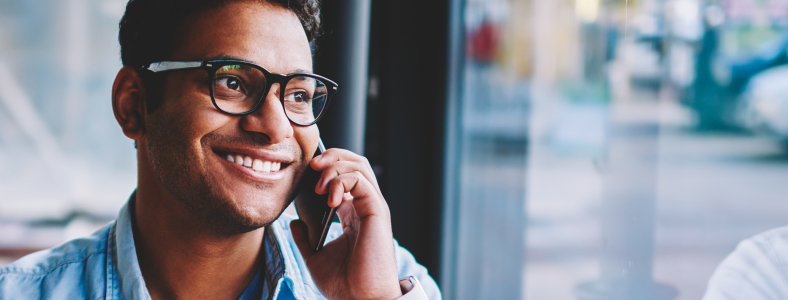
[703,226,788,300]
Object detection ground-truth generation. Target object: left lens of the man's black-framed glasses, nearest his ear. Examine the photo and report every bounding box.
[213,64,265,113]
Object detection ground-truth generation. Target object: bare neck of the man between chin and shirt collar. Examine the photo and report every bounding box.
[132,151,265,299]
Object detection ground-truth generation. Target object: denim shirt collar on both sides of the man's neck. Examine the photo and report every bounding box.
[108,191,290,300]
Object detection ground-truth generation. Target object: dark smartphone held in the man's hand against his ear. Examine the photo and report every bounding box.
[295,140,337,251]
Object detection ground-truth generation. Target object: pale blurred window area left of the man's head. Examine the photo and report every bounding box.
[0,0,136,265]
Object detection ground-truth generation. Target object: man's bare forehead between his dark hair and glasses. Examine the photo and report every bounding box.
[172,1,312,74]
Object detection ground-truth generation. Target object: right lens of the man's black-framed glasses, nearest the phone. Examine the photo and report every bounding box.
[283,76,328,125]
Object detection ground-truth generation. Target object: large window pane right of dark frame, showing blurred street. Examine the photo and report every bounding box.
[444,0,788,299]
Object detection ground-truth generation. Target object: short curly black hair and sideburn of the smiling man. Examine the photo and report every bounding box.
[118,0,320,112]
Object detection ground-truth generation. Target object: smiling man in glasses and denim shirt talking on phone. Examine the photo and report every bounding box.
[0,0,440,299]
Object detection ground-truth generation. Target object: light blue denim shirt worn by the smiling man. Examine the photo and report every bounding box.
[0,196,441,300]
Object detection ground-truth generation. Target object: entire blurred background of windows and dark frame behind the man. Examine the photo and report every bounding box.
[0,0,788,300]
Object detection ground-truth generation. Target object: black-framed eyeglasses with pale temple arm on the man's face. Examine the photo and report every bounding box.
[142,60,337,126]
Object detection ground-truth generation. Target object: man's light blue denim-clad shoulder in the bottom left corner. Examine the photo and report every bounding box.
[0,222,114,299]
